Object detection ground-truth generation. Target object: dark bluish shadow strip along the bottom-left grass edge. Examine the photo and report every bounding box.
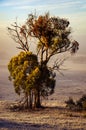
[0,119,58,130]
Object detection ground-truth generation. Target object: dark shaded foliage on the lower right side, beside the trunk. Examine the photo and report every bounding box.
[40,66,55,97]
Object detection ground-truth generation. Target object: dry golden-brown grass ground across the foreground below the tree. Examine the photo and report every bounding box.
[0,101,86,130]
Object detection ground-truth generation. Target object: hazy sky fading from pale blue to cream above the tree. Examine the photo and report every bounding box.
[0,0,86,70]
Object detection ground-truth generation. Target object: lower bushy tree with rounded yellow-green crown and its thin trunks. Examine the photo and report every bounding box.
[8,51,55,108]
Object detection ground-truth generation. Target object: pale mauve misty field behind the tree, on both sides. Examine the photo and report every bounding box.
[0,60,86,103]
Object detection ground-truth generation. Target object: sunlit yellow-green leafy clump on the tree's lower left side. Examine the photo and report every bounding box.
[8,52,38,94]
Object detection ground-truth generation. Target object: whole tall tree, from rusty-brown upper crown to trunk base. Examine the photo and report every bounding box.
[8,13,79,108]
